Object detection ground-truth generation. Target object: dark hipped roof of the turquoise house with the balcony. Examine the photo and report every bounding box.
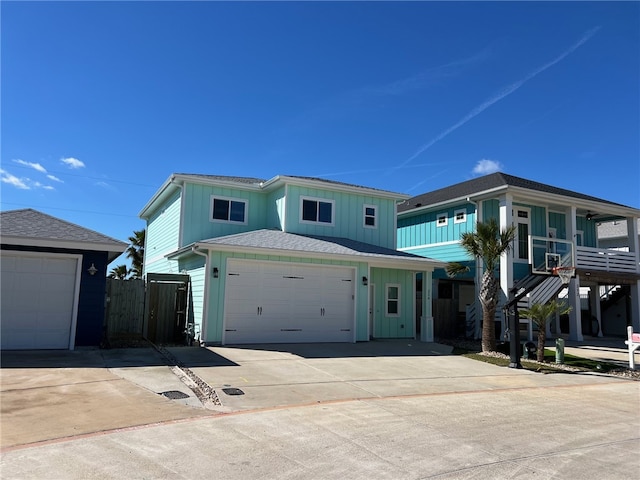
[398,172,626,212]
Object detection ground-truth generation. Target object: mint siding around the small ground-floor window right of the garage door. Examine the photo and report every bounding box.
[369,268,416,338]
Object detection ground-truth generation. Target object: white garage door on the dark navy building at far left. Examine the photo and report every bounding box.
[0,251,79,350]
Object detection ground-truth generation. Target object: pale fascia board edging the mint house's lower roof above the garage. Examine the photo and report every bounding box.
[194,243,445,272]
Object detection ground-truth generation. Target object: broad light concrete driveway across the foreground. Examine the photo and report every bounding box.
[0,341,640,479]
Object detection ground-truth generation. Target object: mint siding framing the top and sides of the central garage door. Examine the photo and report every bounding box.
[203,252,369,344]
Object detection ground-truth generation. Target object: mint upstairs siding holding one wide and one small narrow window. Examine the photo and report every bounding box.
[286,185,396,249]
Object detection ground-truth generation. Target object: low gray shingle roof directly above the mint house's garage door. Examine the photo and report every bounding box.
[197,229,440,264]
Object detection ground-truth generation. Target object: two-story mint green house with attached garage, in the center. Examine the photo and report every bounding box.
[140,174,441,344]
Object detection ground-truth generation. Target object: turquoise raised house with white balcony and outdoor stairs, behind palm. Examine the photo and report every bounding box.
[398,173,640,340]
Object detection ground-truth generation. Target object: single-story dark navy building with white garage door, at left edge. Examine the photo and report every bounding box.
[0,209,127,350]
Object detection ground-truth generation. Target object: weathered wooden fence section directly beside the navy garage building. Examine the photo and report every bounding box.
[105,278,145,338]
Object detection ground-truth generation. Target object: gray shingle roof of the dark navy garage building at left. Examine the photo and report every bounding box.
[0,208,127,252]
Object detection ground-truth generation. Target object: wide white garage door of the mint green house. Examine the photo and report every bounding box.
[224,260,355,344]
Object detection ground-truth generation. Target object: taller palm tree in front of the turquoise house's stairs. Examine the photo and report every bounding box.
[446,218,517,352]
